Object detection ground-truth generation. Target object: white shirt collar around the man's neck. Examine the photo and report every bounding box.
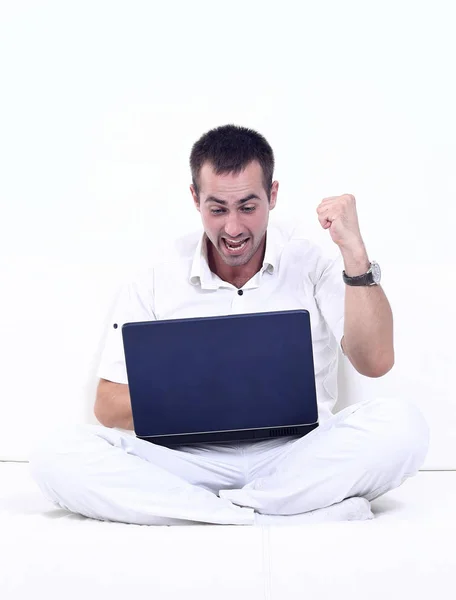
[190,225,283,290]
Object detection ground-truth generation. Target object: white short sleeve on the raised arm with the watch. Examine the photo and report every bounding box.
[315,255,345,353]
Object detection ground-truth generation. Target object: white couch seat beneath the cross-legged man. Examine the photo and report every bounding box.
[0,463,456,600]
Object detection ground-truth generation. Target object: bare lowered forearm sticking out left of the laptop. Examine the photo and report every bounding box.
[94,379,134,429]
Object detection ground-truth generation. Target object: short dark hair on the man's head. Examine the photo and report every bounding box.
[190,125,274,200]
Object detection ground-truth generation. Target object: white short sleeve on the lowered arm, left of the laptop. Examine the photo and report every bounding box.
[97,273,156,384]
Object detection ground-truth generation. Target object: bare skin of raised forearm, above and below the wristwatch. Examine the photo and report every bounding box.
[341,245,394,377]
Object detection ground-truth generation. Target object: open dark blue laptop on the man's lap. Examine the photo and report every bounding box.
[122,310,318,446]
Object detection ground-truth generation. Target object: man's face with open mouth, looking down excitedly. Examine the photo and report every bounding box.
[190,161,279,267]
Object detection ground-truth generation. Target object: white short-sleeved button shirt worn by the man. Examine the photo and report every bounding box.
[97,225,345,422]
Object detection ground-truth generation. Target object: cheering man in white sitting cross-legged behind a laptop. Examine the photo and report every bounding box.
[31,125,428,524]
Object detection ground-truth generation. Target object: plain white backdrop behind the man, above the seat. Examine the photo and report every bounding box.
[0,0,456,468]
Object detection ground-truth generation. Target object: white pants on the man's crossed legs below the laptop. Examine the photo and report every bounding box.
[30,398,429,525]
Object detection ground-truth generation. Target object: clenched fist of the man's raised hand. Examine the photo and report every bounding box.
[317,194,364,252]
